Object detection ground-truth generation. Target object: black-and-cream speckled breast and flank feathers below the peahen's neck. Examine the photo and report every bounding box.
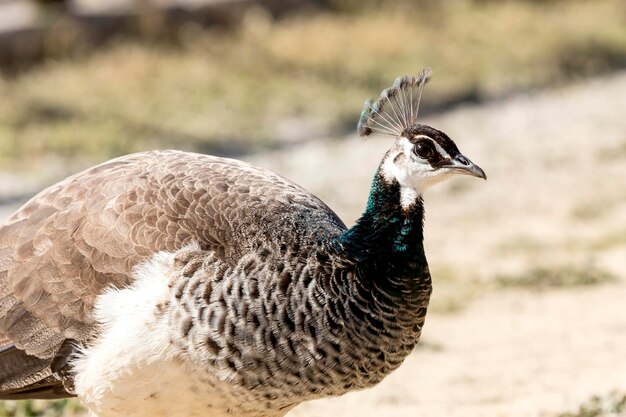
[166,234,430,415]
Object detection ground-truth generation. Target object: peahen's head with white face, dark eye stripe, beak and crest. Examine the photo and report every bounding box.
[359,69,487,206]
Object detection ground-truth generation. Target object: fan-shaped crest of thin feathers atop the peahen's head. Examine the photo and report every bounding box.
[358,68,431,137]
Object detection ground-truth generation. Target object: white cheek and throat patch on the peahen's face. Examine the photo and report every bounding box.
[381,135,452,209]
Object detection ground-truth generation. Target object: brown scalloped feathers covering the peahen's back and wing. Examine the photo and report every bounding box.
[0,151,345,358]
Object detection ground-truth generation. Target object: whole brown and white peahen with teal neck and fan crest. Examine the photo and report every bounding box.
[0,71,485,417]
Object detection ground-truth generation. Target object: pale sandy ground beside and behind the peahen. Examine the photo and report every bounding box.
[0,73,626,417]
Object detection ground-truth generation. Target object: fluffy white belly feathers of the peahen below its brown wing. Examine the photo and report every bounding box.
[75,244,228,417]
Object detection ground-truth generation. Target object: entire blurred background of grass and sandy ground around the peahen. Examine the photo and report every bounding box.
[0,0,626,417]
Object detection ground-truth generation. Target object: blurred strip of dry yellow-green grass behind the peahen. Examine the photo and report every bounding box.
[0,0,626,168]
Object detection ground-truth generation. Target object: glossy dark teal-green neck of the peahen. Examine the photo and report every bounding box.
[335,169,427,280]
